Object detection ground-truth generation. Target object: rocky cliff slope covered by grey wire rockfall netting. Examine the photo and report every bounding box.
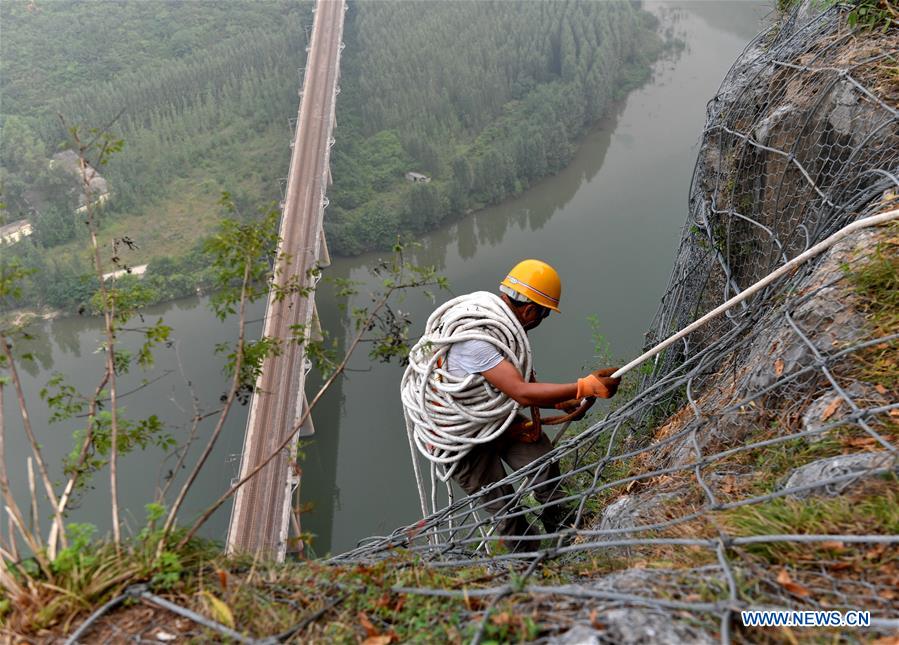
[334,3,899,641]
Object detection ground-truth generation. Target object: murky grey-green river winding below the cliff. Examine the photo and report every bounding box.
[2,1,770,555]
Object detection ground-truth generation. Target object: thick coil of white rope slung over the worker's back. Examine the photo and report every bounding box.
[401,291,531,506]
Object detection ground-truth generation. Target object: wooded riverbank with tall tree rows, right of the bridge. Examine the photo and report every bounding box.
[326,1,659,253]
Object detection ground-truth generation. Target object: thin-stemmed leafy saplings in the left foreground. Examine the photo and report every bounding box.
[0,119,446,628]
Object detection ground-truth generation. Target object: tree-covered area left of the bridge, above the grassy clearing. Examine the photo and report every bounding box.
[0,0,311,216]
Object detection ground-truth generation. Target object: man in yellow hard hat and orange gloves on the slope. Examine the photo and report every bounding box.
[436,260,620,551]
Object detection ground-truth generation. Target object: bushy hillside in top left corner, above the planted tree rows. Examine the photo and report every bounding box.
[0,0,309,114]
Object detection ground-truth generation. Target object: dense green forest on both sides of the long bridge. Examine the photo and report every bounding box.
[0,0,660,309]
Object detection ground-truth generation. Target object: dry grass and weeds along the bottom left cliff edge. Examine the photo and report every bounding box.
[4,555,539,644]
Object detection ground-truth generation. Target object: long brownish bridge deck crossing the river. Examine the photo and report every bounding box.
[227,0,345,559]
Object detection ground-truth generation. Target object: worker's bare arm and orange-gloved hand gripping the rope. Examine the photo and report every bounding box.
[481,359,619,408]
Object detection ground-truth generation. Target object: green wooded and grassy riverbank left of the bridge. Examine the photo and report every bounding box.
[0,0,312,308]
